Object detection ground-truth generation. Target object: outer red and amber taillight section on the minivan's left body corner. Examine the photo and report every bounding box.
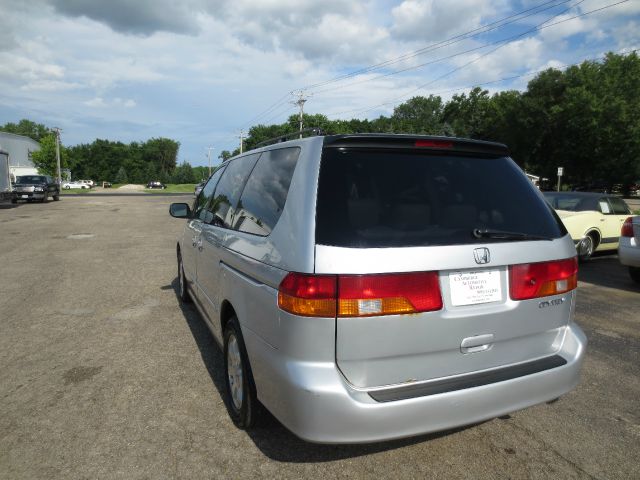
[278,273,337,317]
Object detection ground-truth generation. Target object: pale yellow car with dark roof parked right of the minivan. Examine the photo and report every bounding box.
[544,192,631,261]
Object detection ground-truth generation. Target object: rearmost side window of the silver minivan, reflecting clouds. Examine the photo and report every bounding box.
[233,147,300,236]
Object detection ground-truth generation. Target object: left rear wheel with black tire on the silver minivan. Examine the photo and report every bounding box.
[223,316,261,430]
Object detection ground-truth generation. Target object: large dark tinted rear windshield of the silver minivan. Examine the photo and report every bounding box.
[316,148,564,248]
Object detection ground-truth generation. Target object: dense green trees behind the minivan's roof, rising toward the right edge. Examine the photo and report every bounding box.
[232,52,640,193]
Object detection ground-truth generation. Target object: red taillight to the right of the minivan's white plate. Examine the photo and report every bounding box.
[509,257,578,300]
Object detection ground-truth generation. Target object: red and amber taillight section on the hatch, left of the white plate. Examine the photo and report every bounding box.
[338,272,442,317]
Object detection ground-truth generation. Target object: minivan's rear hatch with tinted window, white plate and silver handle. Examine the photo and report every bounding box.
[315,136,575,388]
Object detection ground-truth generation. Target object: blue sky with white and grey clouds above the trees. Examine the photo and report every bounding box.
[0,0,640,165]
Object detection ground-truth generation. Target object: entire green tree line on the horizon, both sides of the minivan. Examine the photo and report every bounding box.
[0,52,640,188]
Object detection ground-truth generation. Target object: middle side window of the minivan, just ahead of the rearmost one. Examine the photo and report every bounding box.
[207,153,260,228]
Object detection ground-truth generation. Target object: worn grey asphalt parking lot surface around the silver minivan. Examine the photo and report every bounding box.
[0,196,640,479]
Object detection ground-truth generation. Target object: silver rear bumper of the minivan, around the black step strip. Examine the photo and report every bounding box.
[245,324,587,443]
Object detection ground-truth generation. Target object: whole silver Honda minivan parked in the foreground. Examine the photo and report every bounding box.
[170,134,586,443]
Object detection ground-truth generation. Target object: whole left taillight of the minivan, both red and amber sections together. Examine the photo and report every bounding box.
[278,272,442,317]
